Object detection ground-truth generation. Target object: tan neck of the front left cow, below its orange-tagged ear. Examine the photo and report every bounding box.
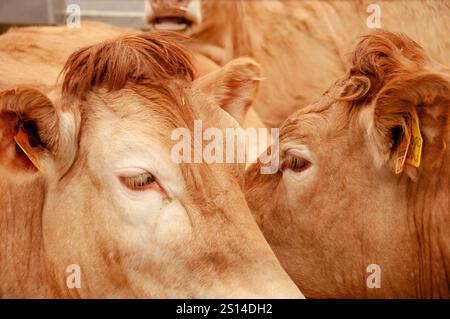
[0,178,52,298]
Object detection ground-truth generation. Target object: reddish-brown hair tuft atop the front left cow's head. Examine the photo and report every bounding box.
[63,32,194,97]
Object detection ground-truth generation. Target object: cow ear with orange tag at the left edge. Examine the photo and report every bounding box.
[0,88,76,179]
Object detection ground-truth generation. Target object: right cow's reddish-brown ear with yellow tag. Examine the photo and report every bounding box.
[373,72,450,178]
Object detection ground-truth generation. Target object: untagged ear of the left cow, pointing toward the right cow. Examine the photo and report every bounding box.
[196,58,262,125]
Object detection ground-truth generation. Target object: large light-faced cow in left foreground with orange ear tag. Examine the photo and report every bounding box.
[0,32,302,298]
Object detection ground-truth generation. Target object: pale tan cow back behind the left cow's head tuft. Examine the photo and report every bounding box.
[0,21,138,88]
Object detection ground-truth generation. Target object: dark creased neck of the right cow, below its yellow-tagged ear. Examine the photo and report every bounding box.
[407,141,450,298]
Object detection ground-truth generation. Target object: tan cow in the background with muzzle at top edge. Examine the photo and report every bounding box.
[146,0,450,127]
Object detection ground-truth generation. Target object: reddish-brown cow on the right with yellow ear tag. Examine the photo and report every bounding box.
[245,31,450,298]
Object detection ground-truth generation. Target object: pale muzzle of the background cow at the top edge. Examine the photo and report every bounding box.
[145,0,202,32]
